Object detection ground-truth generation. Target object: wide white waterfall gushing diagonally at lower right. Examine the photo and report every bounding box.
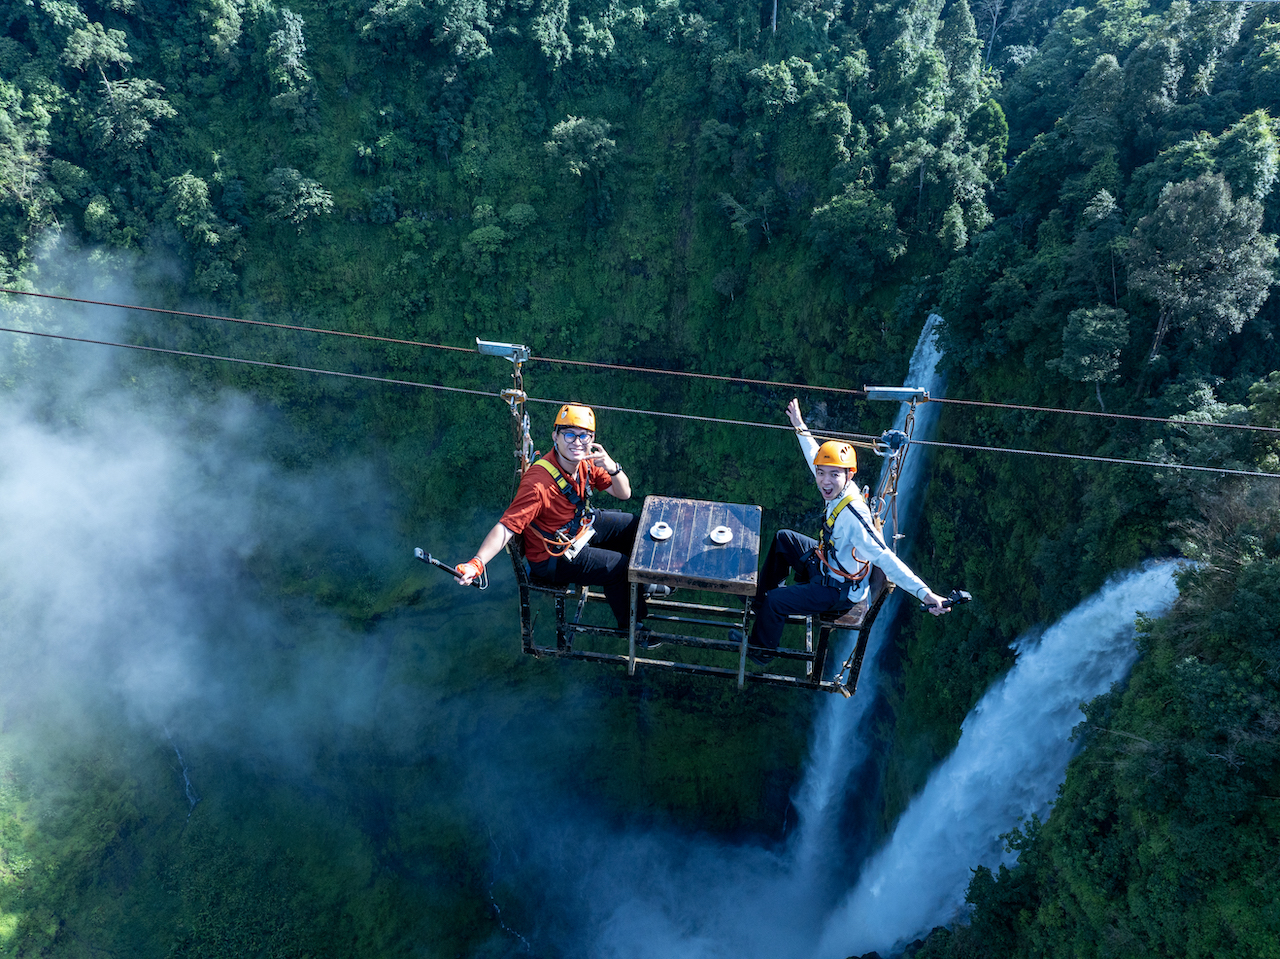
[818,563,1178,958]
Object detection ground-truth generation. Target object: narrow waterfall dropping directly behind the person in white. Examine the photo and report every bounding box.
[795,314,946,885]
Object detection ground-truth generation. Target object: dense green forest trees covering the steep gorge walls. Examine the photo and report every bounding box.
[0,0,1280,956]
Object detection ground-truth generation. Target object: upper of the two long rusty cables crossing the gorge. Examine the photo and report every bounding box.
[0,287,1280,433]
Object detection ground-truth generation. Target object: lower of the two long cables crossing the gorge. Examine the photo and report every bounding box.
[0,326,1280,479]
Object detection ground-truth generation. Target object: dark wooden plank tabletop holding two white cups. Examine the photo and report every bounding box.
[628,496,763,595]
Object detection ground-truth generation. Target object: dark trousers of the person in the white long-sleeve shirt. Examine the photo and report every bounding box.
[751,530,852,649]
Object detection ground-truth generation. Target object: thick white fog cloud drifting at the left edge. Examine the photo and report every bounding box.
[0,250,473,783]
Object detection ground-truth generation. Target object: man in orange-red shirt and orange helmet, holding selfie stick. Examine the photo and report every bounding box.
[457,403,671,630]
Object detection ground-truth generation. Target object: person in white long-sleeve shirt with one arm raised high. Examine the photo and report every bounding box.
[751,399,948,662]
